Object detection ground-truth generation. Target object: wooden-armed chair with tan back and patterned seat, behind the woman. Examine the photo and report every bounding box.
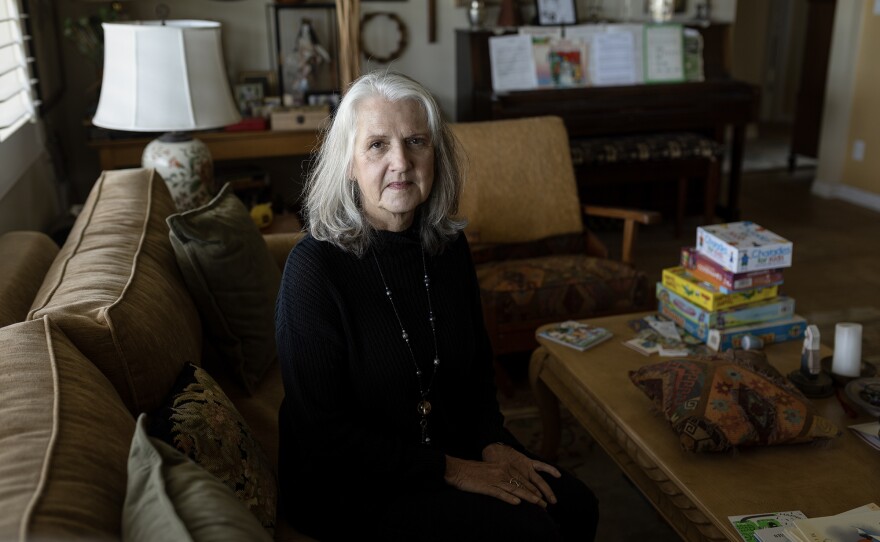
[452,116,660,394]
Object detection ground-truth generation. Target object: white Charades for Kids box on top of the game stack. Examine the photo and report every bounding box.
[697,221,792,273]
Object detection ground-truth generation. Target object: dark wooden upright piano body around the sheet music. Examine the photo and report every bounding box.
[456,24,760,220]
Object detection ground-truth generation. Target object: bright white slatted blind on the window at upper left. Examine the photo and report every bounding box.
[0,0,37,141]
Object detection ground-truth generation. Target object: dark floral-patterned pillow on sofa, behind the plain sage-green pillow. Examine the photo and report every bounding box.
[149,364,278,532]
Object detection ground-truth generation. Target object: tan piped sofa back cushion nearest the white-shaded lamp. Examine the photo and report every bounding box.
[28,169,202,414]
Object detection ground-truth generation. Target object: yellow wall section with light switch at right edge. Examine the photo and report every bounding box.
[841,2,880,198]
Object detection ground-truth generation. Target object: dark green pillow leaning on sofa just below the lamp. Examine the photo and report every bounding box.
[167,183,281,391]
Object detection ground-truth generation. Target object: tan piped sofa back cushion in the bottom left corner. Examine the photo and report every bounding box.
[0,318,135,540]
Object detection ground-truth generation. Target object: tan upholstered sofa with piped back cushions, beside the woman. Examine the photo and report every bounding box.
[0,169,307,540]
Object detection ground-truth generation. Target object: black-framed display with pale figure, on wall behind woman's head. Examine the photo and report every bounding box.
[271,3,340,101]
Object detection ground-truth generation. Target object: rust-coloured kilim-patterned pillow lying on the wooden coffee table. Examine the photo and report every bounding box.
[629,350,840,452]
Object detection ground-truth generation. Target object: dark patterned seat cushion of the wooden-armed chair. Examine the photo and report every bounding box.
[477,254,650,325]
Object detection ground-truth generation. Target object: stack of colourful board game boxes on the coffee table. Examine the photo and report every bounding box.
[656,221,807,351]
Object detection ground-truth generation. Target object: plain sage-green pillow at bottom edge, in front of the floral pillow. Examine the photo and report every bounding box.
[122,414,272,542]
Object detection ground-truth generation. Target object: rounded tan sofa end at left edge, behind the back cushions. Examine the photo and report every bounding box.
[0,231,58,327]
